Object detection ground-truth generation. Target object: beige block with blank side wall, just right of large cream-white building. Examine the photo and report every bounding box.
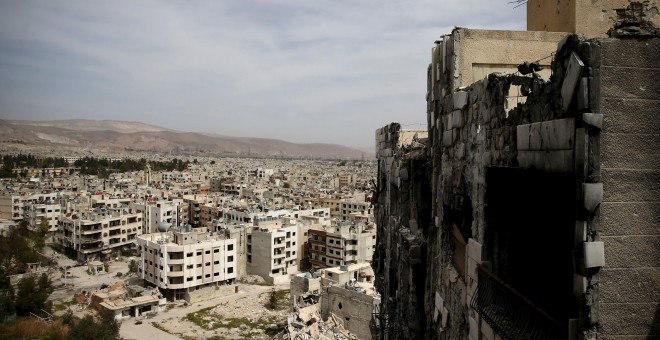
[247,220,298,284]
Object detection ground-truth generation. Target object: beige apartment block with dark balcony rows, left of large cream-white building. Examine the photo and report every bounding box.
[56,206,142,261]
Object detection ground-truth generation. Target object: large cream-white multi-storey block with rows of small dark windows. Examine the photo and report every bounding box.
[137,226,238,300]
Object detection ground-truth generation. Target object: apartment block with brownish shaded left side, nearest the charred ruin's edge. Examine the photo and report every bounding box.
[308,221,376,269]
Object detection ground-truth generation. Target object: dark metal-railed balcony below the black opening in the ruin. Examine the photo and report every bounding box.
[470,266,567,340]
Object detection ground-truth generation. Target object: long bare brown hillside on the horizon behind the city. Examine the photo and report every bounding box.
[0,119,374,159]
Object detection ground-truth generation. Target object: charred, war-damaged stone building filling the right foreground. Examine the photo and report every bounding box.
[373,1,660,340]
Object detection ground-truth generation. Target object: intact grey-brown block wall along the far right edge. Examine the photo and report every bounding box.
[598,39,660,339]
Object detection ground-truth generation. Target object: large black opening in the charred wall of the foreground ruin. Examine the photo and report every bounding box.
[485,167,578,325]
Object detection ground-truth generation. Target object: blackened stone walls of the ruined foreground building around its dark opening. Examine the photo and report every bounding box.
[373,35,660,340]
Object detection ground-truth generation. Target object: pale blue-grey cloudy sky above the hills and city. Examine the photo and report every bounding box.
[0,0,526,148]
